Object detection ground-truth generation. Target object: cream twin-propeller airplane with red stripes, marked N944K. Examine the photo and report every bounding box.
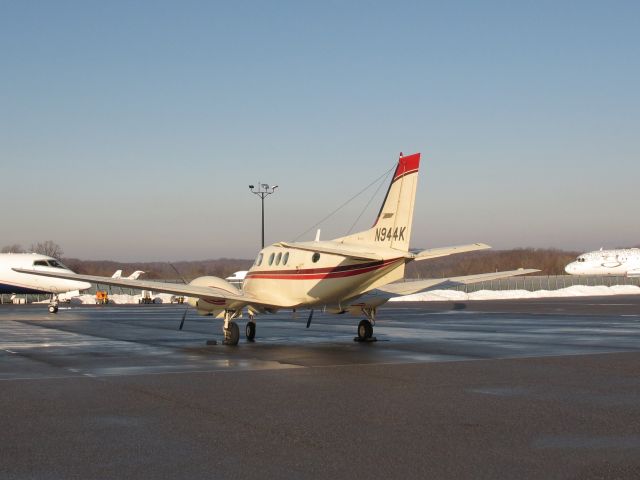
[18,153,537,345]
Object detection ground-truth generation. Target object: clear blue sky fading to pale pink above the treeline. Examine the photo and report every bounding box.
[0,0,640,261]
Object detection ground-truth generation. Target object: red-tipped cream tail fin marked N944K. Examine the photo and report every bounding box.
[336,153,420,252]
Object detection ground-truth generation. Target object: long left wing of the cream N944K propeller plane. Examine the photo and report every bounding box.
[13,268,263,305]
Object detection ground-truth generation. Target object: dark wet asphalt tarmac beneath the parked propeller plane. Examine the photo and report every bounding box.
[0,295,640,479]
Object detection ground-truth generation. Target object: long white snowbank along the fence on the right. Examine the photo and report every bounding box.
[390,285,640,302]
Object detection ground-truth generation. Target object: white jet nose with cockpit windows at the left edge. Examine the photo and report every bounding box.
[0,253,91,313]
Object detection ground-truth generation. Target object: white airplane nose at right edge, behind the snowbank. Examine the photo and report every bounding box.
[564,248,640,277]
